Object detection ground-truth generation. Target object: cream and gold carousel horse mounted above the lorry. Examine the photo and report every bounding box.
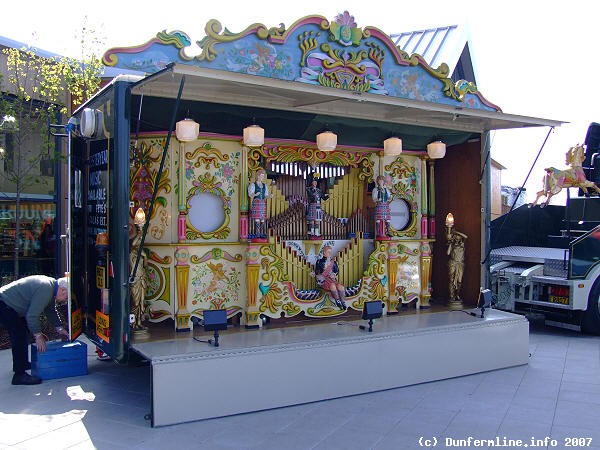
[531,144,600,206]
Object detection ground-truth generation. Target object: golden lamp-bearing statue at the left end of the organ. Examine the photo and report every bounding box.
[129,208,148,331]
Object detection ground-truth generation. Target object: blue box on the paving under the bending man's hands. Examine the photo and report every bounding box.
[31,341,87,380]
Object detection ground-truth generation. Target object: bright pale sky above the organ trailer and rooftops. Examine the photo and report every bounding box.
[0,0,600,204]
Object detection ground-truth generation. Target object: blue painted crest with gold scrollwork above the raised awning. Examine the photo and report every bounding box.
[103,11,500,111]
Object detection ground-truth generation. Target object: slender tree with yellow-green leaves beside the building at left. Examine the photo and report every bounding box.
[0,28,102,278]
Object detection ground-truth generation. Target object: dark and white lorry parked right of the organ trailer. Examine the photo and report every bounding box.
[489,128,600,334]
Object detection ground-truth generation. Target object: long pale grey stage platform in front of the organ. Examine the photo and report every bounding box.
[132,309,529,427]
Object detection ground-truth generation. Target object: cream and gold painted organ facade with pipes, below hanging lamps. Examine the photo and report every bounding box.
[130,135,434,330]
